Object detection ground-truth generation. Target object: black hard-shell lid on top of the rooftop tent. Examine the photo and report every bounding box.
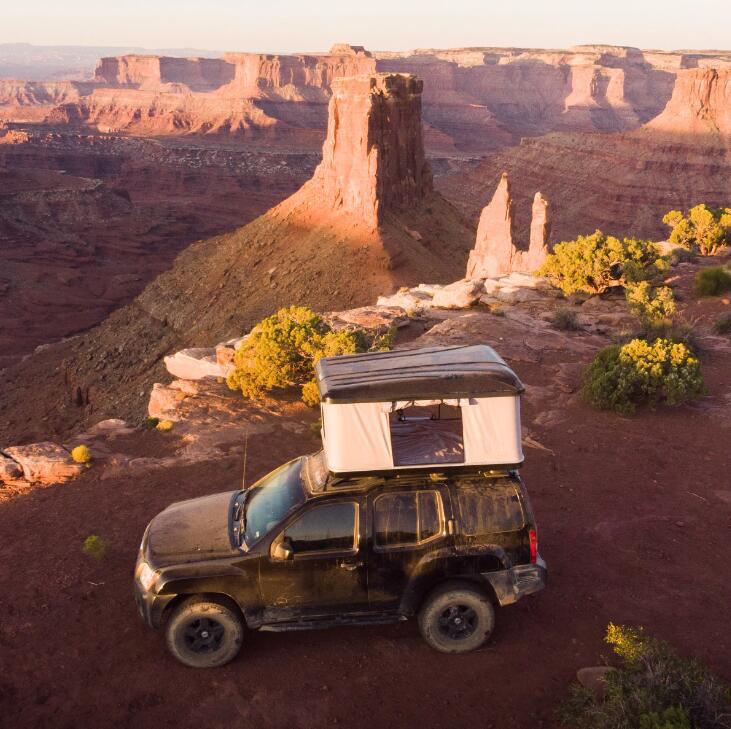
[315,344,525,403]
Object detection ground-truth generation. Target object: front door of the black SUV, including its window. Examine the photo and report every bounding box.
[259,498,368,623]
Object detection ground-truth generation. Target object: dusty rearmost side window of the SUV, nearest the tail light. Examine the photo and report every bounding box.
[456,481,525,537]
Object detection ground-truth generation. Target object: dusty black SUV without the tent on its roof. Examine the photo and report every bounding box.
[135,453,547,667]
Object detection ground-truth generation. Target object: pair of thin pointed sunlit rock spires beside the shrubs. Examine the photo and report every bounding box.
[467,172,550,279]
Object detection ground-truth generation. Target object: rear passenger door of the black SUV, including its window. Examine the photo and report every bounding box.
[368,485,451,612]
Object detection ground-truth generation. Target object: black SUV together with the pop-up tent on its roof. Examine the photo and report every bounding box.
[135,346,547,667]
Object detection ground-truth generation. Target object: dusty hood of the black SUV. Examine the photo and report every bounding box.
[143,491,239,567]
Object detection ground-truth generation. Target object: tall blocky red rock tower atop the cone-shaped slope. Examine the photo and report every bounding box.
[311,74,432,227]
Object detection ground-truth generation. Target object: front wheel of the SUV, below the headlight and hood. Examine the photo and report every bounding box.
[166,597,244,668]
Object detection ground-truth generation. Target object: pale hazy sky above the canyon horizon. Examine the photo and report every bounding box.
[0,0,731,52]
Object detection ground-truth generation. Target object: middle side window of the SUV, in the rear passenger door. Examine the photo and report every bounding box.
[373,491,444,548]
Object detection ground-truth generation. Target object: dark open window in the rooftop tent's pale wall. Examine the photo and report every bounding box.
[389,403,464,466]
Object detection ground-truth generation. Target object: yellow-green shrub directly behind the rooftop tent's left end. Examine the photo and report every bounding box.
[227,306,394,405]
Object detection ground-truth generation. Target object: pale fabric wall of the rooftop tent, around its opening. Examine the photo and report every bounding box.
[322,395,523,473]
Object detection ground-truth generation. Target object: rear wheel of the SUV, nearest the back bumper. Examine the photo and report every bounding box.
[419,585,495,653]
